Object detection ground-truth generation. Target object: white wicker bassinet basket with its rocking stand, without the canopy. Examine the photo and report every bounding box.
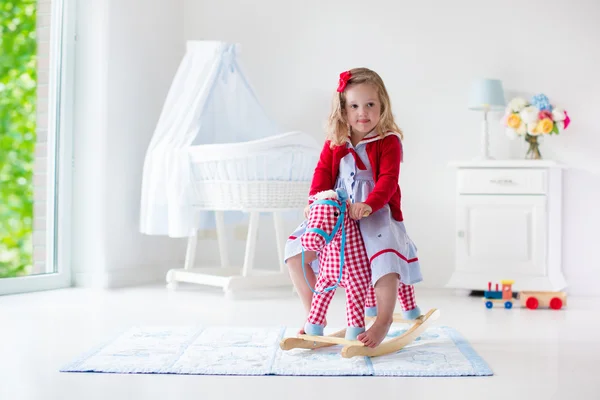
[167,132,319,293]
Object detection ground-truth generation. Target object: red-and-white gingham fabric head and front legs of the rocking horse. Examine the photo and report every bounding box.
[301,193,375,328]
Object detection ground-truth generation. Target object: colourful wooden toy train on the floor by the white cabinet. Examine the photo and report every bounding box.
[483,280,567,310]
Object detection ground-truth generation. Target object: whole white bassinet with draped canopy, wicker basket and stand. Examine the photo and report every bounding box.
[140,41,321,291]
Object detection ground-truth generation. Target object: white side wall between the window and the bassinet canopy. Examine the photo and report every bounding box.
[73,0,185,287]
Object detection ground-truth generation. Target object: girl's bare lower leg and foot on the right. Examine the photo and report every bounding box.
[358,273,398,347]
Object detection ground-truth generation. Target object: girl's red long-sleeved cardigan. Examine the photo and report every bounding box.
[309,133,403,221]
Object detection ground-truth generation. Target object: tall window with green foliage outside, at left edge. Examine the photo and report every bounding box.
[0,0,74,294]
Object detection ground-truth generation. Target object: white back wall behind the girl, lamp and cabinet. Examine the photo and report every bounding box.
[182,0,600,294]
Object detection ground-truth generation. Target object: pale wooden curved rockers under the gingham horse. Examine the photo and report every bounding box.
[279,308,440,358]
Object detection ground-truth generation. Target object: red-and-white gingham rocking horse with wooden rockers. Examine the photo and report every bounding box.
[280,189,439,358]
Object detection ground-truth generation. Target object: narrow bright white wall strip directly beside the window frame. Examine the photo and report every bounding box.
[72,1,108,284]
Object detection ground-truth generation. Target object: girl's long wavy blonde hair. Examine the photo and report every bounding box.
[327,68,404,147]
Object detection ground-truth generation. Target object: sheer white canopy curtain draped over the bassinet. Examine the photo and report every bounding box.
[140,41,278,237]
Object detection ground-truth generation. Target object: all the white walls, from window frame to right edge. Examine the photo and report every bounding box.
[73,0,600,294]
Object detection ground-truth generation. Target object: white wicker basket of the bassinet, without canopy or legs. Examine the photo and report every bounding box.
[189,132,318,211]
